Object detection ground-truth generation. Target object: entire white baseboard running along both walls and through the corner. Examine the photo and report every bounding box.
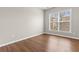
[0,33,79,47]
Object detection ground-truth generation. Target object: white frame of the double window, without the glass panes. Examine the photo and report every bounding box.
[49,9,72,33]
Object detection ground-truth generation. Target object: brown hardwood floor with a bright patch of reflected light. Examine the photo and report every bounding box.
[0,35,79,52]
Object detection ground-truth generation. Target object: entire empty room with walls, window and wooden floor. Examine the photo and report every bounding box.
[0,7,79,52]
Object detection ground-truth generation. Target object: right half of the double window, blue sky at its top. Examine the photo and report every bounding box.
[59,10,71,32]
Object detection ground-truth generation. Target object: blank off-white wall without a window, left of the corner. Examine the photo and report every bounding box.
[0,7,43,45]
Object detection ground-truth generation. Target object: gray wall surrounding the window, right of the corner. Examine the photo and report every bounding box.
[44,7,79,37]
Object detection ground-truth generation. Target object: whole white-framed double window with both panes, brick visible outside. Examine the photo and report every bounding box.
[49,10,71,32]
